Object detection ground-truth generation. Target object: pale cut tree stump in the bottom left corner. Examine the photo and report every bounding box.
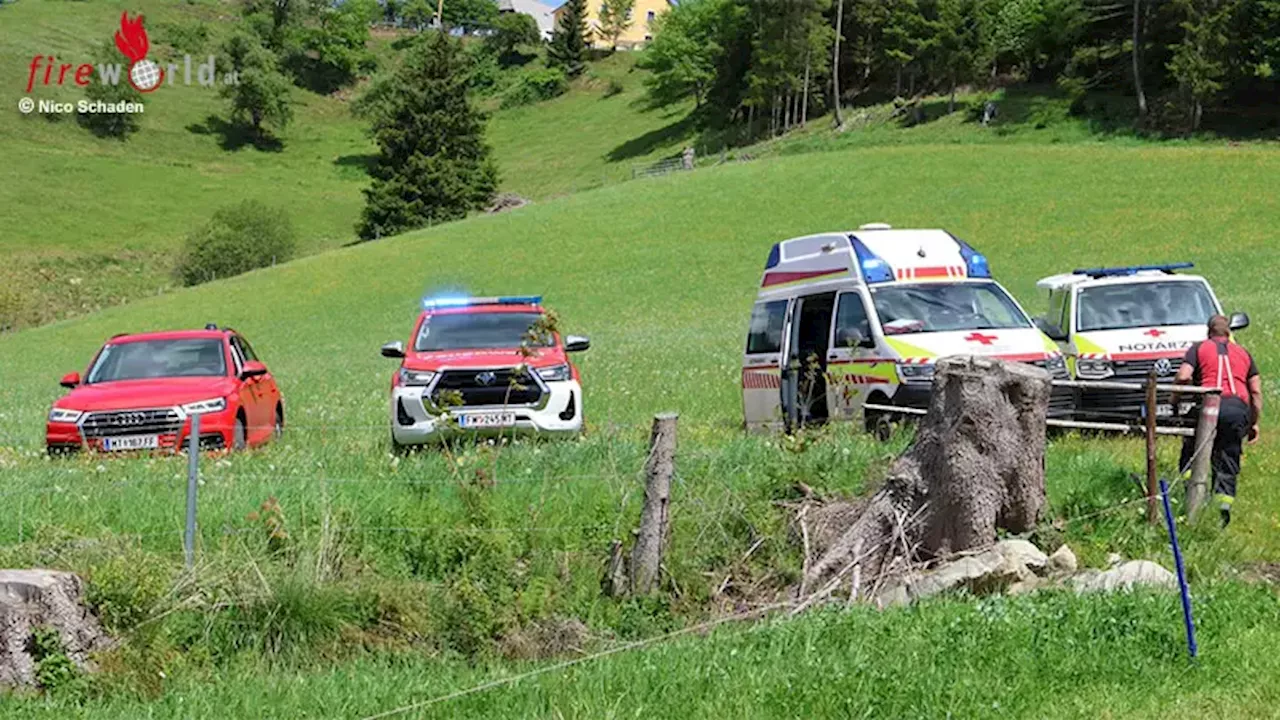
[0,570,108,688]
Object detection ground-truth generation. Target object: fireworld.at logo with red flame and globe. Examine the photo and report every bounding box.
[27,13,239,92]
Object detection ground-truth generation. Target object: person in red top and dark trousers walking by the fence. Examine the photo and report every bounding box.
[1174,315,1262,528]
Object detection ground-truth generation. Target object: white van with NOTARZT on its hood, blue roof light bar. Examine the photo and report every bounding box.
[1036,263,1249,421]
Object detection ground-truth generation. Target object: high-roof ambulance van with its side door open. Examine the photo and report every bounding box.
[742,224,1071,434]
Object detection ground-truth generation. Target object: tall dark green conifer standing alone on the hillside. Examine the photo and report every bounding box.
[357,32,498,240]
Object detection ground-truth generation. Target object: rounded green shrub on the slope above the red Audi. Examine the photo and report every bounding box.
[177,200,296,286]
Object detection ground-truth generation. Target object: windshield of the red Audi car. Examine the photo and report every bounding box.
[86,338,227,384]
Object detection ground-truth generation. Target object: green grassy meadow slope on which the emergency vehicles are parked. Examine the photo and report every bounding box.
[0,146,1280,716]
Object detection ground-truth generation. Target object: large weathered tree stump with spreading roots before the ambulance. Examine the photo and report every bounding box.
[804,357,1051,592]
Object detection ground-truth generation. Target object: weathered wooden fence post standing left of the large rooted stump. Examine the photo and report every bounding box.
[631,413,678,594]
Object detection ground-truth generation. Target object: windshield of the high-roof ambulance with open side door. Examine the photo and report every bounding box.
[872,282,1032,334]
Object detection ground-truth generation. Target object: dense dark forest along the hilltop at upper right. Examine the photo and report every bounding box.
[643,0,1280,137]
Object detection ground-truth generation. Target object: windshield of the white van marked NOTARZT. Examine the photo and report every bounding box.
[1076,281,1219,332]
